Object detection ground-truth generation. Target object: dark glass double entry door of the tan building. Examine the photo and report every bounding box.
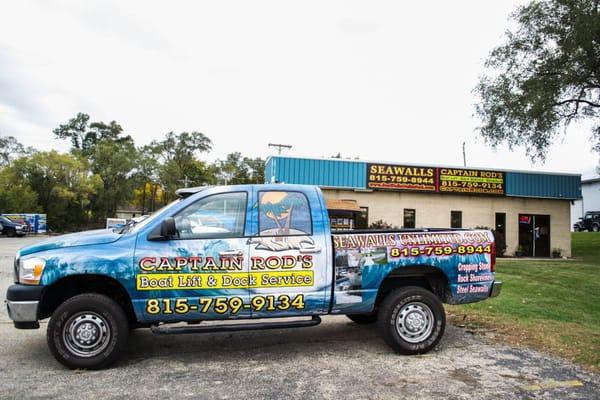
[519,214,550,257]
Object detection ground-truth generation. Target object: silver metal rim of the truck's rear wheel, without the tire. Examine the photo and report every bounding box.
[396,302,434,343]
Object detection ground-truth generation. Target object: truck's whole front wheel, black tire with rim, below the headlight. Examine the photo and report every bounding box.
[46,293,129,369]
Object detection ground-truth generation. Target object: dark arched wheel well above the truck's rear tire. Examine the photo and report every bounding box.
[375,265,450,308]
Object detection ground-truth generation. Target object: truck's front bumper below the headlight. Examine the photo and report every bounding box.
[5,283,44,329]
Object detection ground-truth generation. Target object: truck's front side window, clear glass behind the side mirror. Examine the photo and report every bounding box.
[175,192,247,239]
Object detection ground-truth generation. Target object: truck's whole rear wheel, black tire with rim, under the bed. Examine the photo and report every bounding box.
[377,286,446,354]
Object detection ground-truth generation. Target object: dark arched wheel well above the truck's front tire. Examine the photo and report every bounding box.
[38,275,137,324]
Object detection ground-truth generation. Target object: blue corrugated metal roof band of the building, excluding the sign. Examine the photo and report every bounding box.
[265,156,581,200]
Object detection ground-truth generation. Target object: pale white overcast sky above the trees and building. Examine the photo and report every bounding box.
[0,1,597,172]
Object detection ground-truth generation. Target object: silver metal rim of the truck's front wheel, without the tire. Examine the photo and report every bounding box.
[63,311,111,357]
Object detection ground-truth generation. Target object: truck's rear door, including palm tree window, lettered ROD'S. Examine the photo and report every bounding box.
[249,190,330,318]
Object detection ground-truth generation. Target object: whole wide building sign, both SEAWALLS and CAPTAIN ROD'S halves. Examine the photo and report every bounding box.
[367,164,504,195]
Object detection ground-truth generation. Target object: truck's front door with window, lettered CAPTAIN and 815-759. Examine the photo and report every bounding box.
[134,191,251,321]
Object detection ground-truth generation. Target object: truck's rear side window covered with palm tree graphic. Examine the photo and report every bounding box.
[258,191,312,236]
